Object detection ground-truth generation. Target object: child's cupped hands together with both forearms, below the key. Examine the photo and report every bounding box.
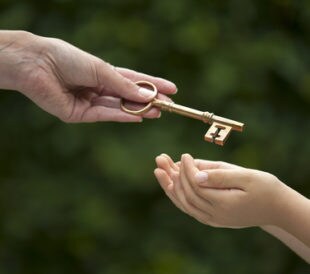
[154,154,310,263]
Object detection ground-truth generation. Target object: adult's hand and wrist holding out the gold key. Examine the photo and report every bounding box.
[0,31,176,122]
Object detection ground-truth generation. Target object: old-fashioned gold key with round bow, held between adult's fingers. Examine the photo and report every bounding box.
[121,81,244,146]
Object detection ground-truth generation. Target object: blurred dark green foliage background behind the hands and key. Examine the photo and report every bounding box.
[0,0,310,274]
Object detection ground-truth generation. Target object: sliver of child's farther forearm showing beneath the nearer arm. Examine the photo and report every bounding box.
[262,225,310,263]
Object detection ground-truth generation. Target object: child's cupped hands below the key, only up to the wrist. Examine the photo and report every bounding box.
[155,154,285,228]
